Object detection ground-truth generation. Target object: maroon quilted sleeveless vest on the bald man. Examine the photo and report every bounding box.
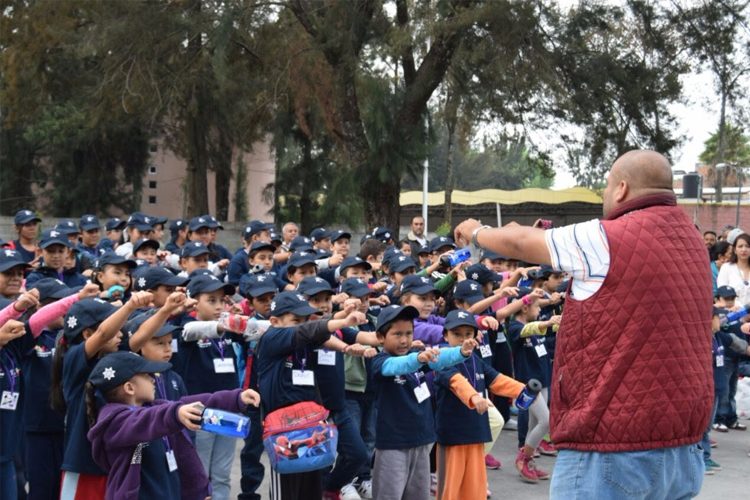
[550,195,713,452]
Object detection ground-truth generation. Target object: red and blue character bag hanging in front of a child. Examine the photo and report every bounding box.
[263,401,338,474]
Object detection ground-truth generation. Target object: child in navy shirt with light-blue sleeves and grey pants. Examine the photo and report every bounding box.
[372,305,477,500]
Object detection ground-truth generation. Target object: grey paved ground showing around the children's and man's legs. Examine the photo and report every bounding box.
[232,421,750,500]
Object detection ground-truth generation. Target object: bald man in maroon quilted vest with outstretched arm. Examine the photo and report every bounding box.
[455,151,713,499]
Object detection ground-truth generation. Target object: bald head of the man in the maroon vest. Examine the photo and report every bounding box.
[602,150,672,217]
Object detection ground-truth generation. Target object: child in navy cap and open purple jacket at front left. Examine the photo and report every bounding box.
[86,352,259,500]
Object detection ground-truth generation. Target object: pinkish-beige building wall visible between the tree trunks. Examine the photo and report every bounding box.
[141,140,276,222]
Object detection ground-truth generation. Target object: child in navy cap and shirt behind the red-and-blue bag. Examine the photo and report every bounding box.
[256,292,365,500]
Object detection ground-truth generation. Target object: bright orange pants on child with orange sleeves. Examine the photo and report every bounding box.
[437,443,487,500]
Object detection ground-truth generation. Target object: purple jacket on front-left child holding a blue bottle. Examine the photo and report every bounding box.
[88,389,245,500]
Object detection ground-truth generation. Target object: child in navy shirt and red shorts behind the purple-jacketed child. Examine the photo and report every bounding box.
[51,292,151,500]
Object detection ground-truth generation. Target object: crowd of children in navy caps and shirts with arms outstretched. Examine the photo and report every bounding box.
[0,210,750,500]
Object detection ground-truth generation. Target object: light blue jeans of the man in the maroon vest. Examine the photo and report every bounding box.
[550,444,705,500]
